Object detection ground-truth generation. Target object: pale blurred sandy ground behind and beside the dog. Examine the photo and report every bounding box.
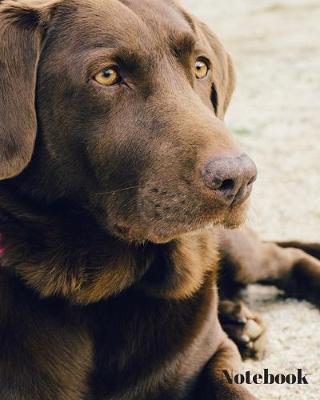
[182,0,320,400]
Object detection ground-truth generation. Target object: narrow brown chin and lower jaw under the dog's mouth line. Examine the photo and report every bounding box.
[112,201,248,244]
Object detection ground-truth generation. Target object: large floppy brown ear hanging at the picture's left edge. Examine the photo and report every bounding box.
[0,0,57,180]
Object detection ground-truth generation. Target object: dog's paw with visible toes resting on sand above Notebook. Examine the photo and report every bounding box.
[219,300,267,360]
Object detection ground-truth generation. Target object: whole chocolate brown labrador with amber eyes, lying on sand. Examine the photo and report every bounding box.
[0,0,320,400]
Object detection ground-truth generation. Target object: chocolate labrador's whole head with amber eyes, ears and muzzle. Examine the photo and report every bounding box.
[0,0,256,242]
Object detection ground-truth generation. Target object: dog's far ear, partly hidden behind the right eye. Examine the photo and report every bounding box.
[197,21,235,119]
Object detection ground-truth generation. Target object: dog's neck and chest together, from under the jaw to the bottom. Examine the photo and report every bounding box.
[0,196,220,400]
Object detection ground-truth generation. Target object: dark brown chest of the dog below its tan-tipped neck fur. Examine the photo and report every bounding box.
[0,274,217,400]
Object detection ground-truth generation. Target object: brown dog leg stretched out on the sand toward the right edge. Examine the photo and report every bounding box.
[219,229,320,306]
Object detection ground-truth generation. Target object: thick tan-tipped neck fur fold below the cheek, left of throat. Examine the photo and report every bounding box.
[0,185,144,303]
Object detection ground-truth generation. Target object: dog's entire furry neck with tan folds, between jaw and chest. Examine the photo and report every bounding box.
[0,186,218,304]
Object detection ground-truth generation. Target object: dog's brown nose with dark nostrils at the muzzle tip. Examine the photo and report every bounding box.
[202,154,257,206]
